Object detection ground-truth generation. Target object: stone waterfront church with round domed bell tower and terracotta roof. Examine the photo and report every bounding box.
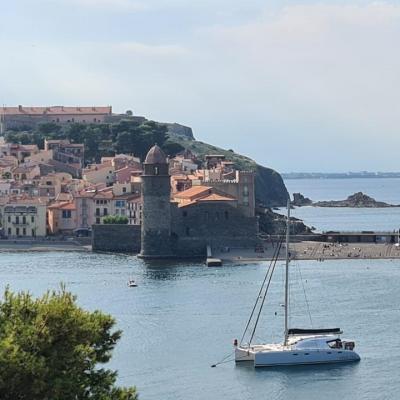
[140,146,258,258]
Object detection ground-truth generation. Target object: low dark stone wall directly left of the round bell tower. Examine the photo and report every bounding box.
[92,224,140,253]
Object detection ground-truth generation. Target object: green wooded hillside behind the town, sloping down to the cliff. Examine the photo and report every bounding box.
[5,116,289,207]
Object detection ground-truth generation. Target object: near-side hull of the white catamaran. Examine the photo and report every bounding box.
[254,349,360,367]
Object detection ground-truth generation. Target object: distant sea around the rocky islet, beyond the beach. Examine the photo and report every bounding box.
[283,178,400,231]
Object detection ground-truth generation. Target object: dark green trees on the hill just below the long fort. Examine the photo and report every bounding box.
[5,115,183,163]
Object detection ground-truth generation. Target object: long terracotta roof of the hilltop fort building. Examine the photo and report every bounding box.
[0,106,112,115]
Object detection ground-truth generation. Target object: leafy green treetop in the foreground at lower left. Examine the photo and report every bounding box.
[0,287,137,400]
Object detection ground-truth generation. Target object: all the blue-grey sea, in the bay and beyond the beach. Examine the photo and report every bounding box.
[0,179,400,400]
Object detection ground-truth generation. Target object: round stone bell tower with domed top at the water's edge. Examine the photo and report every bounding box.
[140,145,173,258]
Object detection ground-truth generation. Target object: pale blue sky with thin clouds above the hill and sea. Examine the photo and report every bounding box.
[0,0,400,172]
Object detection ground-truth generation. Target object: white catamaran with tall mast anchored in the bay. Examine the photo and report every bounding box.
[234,203,360,367]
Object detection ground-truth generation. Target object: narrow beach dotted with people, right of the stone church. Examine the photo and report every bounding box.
[213,241,400,263]
